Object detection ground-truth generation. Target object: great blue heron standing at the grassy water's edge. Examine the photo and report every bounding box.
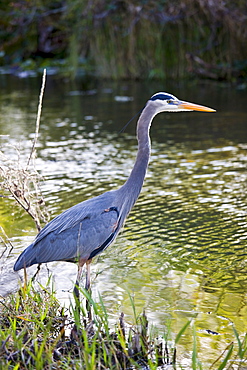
[14,92,215,297]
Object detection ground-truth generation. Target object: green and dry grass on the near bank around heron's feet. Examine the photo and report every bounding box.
[0,281,247,370]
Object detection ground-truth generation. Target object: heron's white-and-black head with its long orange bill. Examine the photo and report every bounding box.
[149,92,215,114]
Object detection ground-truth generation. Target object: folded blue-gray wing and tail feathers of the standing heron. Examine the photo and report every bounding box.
[14,193,121,271]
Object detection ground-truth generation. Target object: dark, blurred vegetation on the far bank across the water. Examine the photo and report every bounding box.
[0,0,247,81]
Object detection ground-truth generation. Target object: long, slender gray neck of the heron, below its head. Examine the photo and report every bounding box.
[122,102,155,207]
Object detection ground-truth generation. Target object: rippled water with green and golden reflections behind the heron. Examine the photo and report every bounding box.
[0,76,247,368]
